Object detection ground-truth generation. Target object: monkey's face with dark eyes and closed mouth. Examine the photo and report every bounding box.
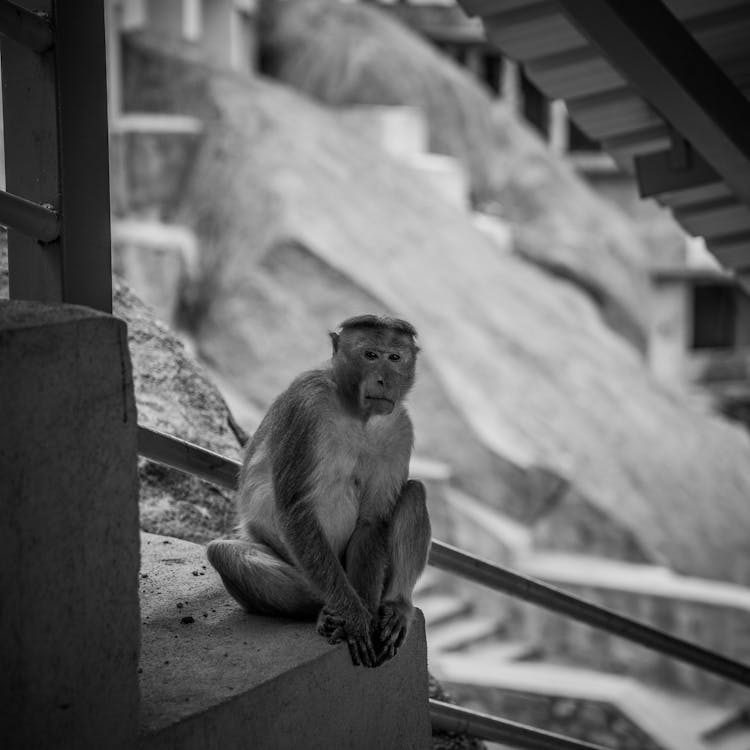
[333,329,416,419]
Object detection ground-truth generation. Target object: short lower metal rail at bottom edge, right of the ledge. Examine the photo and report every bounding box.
[430,698,607,750]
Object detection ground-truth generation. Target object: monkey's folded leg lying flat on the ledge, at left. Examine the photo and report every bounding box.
[206,539,323,620]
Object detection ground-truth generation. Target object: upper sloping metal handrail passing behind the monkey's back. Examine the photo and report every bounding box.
[138,426,750,687]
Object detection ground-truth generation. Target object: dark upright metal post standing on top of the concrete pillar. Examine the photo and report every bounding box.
[0,0,112,312]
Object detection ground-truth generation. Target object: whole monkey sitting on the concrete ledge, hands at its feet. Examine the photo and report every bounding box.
[207,315,431,667]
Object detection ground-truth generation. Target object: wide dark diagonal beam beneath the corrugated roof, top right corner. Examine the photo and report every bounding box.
[557,0,750,206]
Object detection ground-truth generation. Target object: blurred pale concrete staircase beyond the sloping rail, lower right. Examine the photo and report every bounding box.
[415,488,750,750]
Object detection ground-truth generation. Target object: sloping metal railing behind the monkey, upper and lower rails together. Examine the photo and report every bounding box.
[138,426,750,750]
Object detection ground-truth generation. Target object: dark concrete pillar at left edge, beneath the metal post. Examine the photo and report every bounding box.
[0,302,140,750]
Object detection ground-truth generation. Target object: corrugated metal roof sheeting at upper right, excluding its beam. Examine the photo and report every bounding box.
[459,0,750,288]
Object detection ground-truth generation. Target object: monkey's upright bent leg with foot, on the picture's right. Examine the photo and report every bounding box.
[376,480,432,663]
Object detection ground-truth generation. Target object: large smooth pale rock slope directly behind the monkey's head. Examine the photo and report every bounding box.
[116,35,750,581]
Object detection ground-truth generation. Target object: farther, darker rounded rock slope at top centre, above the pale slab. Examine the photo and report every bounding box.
[261,0,648,347]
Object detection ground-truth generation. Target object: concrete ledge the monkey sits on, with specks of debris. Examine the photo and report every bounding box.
[140,533,430,750]
